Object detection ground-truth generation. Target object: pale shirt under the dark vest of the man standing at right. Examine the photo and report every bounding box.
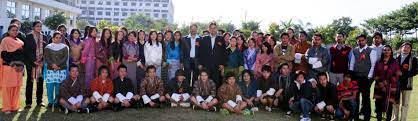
[349,45,377,78]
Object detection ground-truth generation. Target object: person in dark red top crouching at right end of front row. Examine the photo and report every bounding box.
[335,73,359,120]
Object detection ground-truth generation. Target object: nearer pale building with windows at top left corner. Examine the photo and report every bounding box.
[0,0,81,34]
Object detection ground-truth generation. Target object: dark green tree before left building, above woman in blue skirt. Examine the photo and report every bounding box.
[44,12,68,30]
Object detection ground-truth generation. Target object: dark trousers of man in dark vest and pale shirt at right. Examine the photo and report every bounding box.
[355,76,373,121]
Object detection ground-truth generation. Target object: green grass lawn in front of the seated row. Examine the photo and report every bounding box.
[0,75,418,121]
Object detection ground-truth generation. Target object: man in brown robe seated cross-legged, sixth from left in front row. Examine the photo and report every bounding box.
[190,70,218,111]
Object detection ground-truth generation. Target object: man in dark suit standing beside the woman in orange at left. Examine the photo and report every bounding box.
[23,21,48,109]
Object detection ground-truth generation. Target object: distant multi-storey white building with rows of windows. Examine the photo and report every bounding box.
[79,0,174,25]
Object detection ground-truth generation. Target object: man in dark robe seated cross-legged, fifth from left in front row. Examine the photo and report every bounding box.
[165,69,191,107]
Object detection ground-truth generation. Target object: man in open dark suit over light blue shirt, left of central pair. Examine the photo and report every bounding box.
[180,24,201,86]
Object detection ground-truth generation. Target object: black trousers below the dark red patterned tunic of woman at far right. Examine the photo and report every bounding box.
[375,99,392,121]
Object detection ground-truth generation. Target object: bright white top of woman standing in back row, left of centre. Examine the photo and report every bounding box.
[144,42,163,67]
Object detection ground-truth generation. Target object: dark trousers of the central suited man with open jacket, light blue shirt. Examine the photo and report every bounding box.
[184,58,199,87]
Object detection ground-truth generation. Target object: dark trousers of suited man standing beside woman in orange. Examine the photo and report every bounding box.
[25,66,44,105]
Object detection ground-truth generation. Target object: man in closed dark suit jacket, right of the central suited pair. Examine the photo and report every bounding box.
[198,22,227,87]
